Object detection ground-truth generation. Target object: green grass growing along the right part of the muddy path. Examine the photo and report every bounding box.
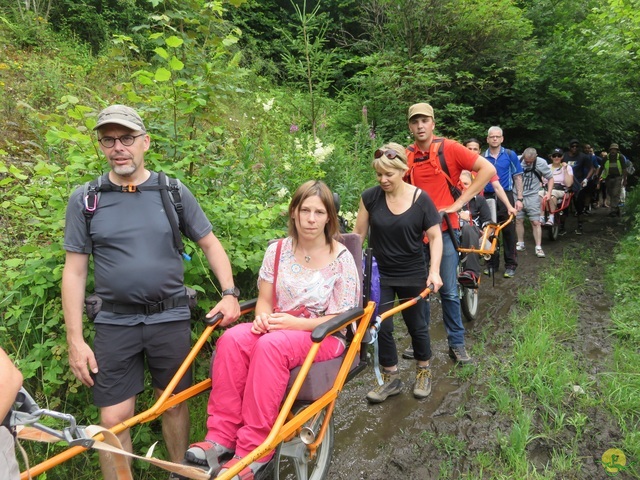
[465,192,640,479]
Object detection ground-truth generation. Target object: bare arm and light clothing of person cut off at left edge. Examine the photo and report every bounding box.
[0,348,22,480]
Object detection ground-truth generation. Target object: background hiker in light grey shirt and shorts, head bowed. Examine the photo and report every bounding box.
[516,148,553,258]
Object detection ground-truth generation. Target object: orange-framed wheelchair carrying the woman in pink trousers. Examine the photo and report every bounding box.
[19,234,430,480]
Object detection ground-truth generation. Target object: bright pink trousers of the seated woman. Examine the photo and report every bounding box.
[206,323,345,461]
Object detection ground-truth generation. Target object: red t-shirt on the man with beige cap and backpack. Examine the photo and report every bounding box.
[407,138,478,228]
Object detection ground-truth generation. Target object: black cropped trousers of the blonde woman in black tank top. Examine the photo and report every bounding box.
[378,284,431,368]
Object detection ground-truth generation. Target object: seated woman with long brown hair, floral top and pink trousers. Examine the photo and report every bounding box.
[180,180,360,479]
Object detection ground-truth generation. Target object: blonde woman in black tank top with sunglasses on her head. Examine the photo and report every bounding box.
[354,143,442,403]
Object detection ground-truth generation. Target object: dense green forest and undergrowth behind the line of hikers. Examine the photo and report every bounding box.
[0,0,640,476]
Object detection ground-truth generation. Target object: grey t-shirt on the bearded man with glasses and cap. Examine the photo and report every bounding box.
[64,172,212,325]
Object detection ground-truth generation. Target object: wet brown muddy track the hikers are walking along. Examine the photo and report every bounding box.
[328,209,623,480]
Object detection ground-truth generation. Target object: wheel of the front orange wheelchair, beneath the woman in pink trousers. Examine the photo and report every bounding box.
[273,409,335,480]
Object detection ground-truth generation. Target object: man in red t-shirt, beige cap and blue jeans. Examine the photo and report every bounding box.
[406,103,496,363]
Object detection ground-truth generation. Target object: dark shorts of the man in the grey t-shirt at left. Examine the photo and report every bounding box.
[93,320,191,407]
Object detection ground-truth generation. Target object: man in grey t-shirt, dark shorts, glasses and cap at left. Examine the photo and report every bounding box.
[62,105,240,480]
